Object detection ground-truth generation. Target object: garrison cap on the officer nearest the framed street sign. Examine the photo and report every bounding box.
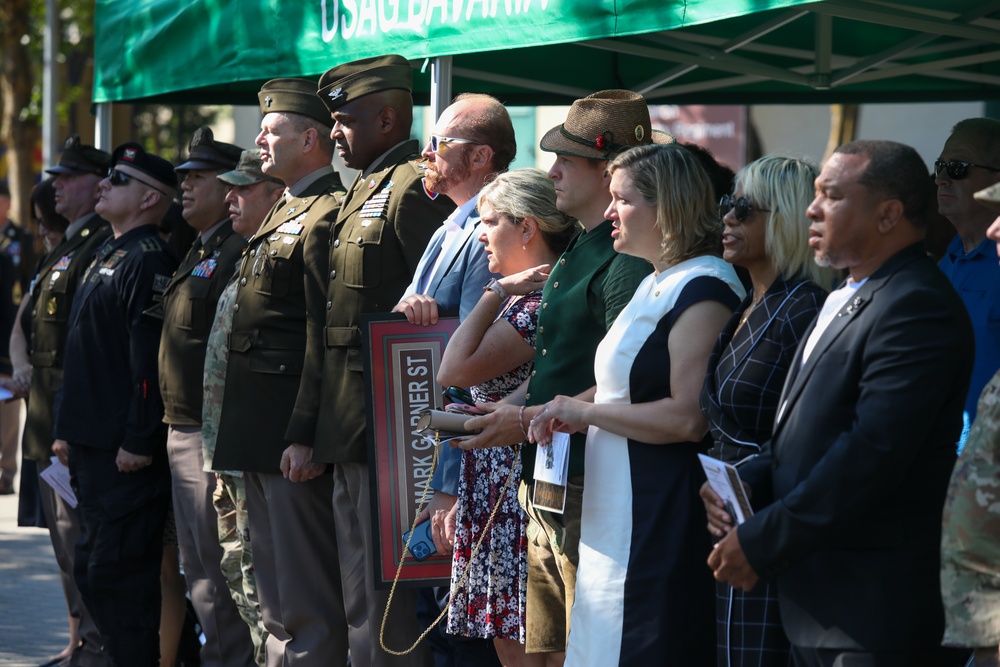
[316,55,413,113]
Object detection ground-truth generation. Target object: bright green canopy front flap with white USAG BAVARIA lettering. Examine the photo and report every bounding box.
[94,0,802,104]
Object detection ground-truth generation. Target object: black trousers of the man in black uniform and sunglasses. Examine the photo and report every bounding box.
[69,443,170,667]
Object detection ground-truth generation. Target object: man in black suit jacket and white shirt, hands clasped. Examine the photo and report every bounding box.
[702,141,973,667]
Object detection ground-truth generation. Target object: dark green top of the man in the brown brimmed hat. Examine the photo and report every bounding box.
[521,220,653,481]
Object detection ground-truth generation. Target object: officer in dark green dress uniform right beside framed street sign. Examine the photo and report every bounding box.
[286,56,455,667]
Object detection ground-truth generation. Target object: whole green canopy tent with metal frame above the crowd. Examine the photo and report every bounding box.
[94,0,1000,104]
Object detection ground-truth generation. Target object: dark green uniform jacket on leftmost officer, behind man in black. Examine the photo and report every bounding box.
[24,213,111,462]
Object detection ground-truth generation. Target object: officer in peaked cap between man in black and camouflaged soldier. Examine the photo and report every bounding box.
[160,127,254,667]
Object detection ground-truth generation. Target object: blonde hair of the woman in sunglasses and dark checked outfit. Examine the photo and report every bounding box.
[735,155,836,289]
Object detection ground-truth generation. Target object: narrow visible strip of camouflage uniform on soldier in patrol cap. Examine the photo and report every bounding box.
[201,276,267,667]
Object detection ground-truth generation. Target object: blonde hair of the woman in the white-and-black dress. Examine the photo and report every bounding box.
[608,144,722,265]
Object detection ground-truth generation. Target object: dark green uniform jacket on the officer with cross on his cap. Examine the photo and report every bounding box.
[212,172,344,473]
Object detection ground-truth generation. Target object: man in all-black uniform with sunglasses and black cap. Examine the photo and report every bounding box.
[55,143,177,665]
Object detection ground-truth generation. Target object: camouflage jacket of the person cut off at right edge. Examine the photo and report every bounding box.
[941,372,1000,648]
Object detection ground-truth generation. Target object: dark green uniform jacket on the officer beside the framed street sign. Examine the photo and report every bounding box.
[288,141,455,463]
